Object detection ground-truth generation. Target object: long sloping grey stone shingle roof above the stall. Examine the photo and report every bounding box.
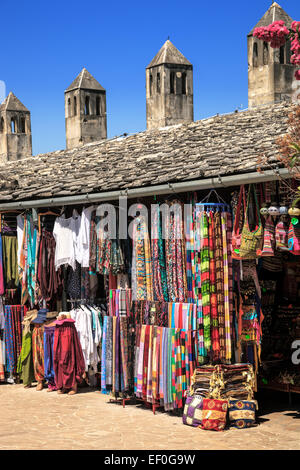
[0,102,292,202]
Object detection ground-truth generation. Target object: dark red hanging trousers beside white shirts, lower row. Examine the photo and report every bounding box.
[53,319,85,390]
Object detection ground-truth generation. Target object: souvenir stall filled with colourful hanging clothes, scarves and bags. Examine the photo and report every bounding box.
[0,181,300,430]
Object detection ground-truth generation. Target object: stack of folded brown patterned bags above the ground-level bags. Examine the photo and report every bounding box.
[190,364,255,400]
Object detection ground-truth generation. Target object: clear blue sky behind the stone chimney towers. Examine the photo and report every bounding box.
[0,0,300,155]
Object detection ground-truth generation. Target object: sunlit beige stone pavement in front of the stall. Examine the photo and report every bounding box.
[0,384,300,450]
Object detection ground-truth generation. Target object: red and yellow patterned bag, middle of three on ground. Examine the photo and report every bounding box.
[201,398,228,431]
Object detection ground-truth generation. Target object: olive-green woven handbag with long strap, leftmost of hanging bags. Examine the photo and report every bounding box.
[239,184,263,259]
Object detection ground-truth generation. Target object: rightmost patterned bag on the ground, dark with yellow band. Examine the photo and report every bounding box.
[228,400,257,429]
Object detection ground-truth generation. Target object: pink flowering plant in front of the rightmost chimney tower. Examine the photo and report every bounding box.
[253,21,300,80]
